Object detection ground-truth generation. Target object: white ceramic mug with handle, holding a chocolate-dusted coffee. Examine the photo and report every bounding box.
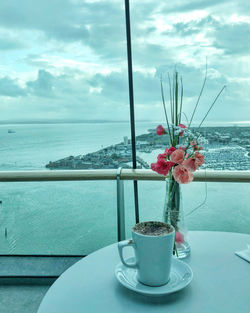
[118,221,175,286]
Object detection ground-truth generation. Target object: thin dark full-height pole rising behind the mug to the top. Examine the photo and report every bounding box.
[125,0,139,223]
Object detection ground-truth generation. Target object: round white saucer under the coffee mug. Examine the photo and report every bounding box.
[115,257,193,297]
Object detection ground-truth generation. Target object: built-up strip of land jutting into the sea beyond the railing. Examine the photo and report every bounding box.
[45,127,250,171]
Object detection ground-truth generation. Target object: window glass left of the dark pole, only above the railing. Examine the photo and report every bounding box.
[0,0,131,170]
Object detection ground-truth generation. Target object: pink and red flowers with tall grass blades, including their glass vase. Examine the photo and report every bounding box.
[151,71,225,257]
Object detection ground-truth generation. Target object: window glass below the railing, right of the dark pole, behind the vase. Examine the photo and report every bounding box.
[136,181,250,233]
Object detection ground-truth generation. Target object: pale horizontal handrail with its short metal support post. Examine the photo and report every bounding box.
[0,168,250,241]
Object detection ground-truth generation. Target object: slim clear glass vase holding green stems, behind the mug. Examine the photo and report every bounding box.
[163,175,190,259]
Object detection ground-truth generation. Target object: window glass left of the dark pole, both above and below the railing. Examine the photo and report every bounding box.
[0,0,131,254]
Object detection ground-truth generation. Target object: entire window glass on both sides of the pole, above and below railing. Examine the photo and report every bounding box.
[0,0,250,254]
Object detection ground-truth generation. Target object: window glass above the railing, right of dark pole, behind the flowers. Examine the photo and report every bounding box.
[131,0,250,170]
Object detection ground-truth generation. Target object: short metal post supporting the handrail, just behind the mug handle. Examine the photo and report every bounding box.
[116,167,126,241]
